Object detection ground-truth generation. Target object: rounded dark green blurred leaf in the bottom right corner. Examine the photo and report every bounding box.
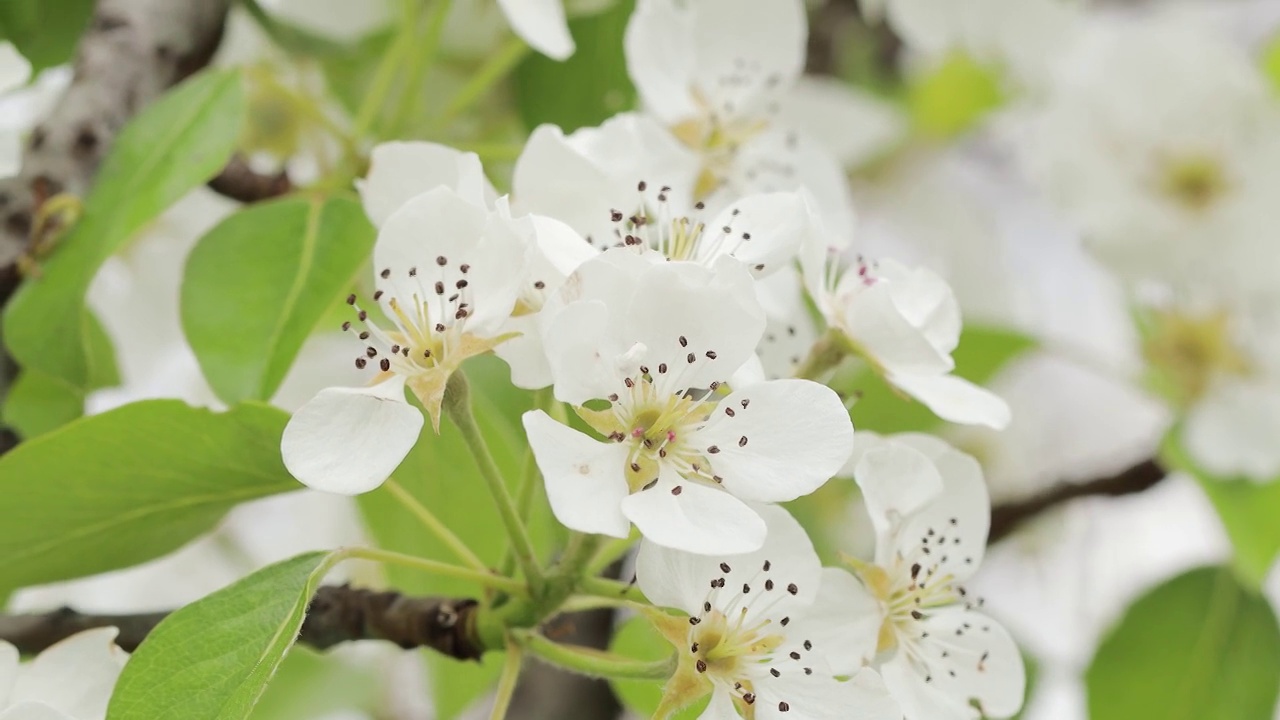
[1085,568,1280,720]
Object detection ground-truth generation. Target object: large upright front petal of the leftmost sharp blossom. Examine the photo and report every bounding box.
[374,187,532,334]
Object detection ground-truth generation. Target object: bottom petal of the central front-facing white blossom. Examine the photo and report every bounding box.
[622,468,767,555]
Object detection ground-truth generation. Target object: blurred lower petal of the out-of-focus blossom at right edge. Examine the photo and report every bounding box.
[1183,383,1280,482]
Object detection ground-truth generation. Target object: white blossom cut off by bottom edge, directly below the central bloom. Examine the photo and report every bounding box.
[636,506,902,720]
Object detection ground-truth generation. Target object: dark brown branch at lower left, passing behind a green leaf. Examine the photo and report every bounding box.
[0,585,484,660]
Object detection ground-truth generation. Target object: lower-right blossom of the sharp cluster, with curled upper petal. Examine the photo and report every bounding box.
[837,433,1025,720]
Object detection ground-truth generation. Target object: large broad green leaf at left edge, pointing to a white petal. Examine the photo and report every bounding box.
[0,400,301,591]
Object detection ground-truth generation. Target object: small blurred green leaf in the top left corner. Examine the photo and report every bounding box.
[0,0,93,73]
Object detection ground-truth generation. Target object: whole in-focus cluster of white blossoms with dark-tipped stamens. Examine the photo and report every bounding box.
[283,0,1024,720]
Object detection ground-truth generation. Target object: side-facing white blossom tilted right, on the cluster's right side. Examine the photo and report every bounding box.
[804,242,1009,429]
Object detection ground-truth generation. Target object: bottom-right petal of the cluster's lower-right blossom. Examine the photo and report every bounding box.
[906,606,1027,720]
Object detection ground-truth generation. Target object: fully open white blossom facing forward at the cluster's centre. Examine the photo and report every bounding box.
[525,249,852,553]
